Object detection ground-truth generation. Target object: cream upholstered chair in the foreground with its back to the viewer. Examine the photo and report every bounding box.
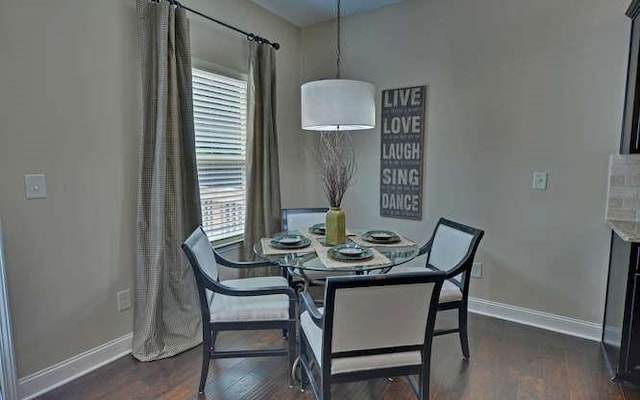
[300,271,445,400]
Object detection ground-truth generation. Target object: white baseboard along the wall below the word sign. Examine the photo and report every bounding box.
[469,297,602,342]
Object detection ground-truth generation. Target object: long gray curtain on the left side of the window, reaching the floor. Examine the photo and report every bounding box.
[133,0,202,361]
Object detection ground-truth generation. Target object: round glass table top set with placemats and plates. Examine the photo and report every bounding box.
[253,231,420,273]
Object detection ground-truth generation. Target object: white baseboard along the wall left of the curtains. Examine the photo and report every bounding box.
[18,333,133,400]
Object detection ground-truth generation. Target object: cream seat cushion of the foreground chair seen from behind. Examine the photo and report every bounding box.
[300,308,422,375]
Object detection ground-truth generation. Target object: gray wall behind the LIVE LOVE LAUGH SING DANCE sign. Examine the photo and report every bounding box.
[302,0,630,322]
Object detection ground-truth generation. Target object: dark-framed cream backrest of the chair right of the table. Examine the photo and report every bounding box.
[427,218,484,279]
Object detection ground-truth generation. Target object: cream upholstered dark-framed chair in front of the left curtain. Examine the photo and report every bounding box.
[182,227,296,393]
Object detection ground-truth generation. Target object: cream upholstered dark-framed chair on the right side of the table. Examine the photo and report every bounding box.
[390,218,484,358]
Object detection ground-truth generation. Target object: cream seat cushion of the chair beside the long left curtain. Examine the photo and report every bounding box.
[209,276,289,322]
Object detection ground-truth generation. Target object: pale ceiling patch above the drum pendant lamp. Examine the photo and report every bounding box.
[251,0,403,28]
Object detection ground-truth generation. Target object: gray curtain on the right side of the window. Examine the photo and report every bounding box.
[243,42,280,277]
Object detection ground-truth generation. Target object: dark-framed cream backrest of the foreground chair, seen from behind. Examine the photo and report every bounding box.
[322,271,445,365]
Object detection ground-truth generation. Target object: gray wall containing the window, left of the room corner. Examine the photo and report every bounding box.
[0,0,304,377]
